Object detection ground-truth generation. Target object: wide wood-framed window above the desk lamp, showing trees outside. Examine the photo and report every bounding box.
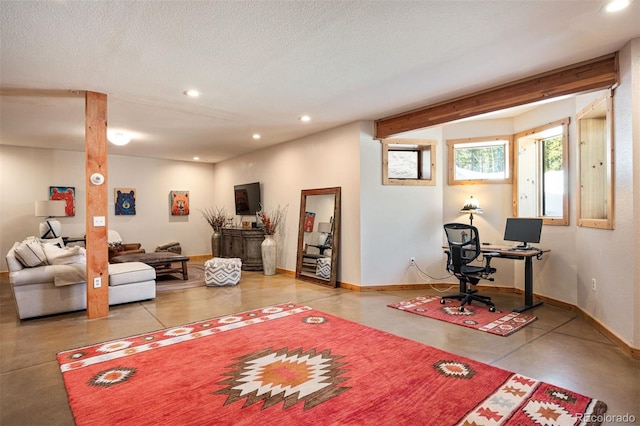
[447,136,511,185]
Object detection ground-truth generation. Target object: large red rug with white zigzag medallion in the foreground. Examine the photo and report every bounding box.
[58,303,606,426]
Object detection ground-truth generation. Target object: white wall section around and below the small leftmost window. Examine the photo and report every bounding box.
[360,123,445,286]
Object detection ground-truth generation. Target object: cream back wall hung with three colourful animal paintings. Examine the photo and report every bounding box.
[0,145,215,270]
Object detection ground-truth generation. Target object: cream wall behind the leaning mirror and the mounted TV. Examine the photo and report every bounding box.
[211,123,360,283]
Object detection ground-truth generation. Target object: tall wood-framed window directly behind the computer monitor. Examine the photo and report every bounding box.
[513,118,569,225]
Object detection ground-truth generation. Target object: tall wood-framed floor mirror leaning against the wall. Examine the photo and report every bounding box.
[296,187,340,287]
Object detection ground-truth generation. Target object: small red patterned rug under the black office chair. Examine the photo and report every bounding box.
[388,296,538,336]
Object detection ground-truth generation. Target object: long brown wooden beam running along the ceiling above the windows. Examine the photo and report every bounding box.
[375,52,619,139]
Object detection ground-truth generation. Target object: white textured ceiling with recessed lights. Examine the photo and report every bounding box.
[0,0,640,162]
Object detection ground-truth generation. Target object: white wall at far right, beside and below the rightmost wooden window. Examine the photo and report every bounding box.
[576,39,640,347]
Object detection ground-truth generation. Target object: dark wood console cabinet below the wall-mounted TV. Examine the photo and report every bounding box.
[220,228,264,271]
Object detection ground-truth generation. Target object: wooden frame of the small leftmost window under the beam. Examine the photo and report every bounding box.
[380,138,437,186]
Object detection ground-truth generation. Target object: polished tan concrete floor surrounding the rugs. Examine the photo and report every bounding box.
[0,264,640,426]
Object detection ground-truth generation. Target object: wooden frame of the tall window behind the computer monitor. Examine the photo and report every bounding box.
[513,117,571,226]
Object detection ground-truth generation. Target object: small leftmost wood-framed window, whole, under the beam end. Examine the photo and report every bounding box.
[382,139,436,185]
